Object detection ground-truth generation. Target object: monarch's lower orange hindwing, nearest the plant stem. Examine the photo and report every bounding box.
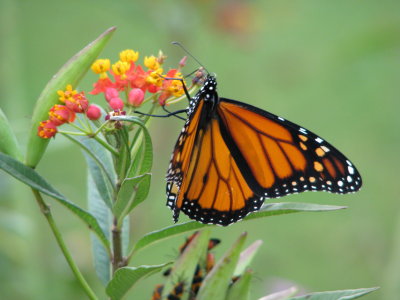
[167,97,263,225]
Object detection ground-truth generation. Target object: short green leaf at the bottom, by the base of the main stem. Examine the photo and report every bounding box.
[106,263,171,300]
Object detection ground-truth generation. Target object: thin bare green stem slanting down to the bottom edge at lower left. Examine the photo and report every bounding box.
[32,188,98,300]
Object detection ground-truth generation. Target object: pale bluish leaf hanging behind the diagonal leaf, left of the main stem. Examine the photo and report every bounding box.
[87,170,112,286]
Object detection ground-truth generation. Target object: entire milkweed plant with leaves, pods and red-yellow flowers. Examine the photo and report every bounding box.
[0,28,375,300]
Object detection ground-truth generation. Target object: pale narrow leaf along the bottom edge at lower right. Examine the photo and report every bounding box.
[289,287,378,300]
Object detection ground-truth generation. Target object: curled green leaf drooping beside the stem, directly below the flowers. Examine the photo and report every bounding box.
[111,116,153,220]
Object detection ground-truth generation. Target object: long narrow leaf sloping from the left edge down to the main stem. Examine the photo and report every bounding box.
[0,153,110,249]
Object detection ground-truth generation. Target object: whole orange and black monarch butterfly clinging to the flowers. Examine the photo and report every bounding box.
[166,74,362,226]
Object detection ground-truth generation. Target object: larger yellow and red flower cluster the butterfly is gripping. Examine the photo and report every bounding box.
[90,49,186,110]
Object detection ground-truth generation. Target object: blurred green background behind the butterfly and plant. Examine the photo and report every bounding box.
[0,0,400,300]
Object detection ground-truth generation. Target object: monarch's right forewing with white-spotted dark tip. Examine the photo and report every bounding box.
[218,98,362,198]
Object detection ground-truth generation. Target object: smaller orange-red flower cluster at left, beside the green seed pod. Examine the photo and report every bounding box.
[38,84,101,139]
